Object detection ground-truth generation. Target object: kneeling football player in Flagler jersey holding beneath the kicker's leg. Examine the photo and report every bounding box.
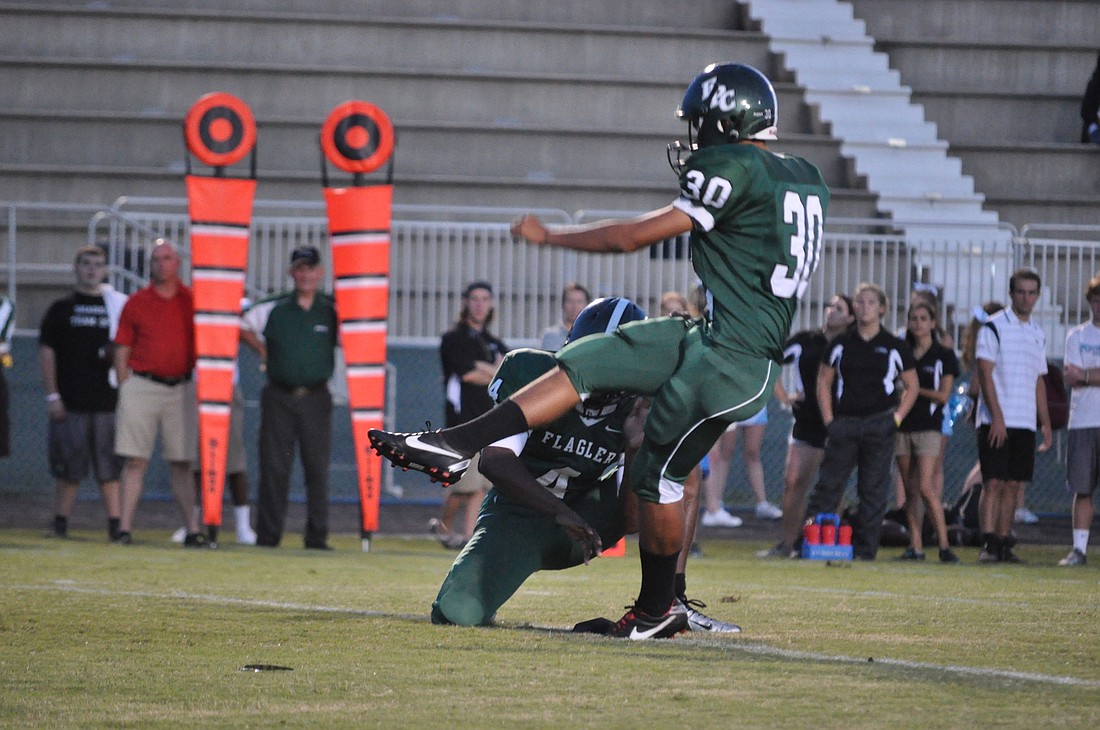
[431,297,739,633]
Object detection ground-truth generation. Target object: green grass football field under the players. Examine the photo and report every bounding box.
[0,530,1100,730]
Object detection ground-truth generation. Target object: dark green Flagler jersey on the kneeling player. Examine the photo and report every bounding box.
[488,350,634,497]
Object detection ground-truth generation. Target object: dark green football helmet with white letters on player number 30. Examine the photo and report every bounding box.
[668,64,779,174]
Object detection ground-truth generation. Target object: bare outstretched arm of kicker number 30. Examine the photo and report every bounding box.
[512,206,692,253]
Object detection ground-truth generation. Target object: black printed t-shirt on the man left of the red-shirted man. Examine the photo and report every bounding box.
[39,292,119,412]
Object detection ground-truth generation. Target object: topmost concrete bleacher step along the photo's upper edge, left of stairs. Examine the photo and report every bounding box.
[3,0,739,29]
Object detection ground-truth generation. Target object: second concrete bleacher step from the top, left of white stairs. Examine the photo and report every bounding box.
[0,4,768,79]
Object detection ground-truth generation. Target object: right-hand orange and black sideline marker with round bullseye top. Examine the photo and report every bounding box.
[320,101,396,549]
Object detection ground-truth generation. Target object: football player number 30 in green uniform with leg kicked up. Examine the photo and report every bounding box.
[370,64,829,639]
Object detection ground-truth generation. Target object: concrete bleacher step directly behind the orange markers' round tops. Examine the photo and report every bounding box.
[0,112,850,187]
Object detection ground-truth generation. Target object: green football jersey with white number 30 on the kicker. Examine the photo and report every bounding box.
[673,143,829,362]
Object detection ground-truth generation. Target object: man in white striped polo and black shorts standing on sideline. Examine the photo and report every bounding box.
[976,269,1052,563]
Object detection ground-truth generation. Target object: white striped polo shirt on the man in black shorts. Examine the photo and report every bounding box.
[977,308,1046,431]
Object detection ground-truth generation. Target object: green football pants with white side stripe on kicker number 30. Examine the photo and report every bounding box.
[556,317,780,504]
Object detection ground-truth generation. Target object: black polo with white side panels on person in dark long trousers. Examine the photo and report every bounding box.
[822,328,916,417]
